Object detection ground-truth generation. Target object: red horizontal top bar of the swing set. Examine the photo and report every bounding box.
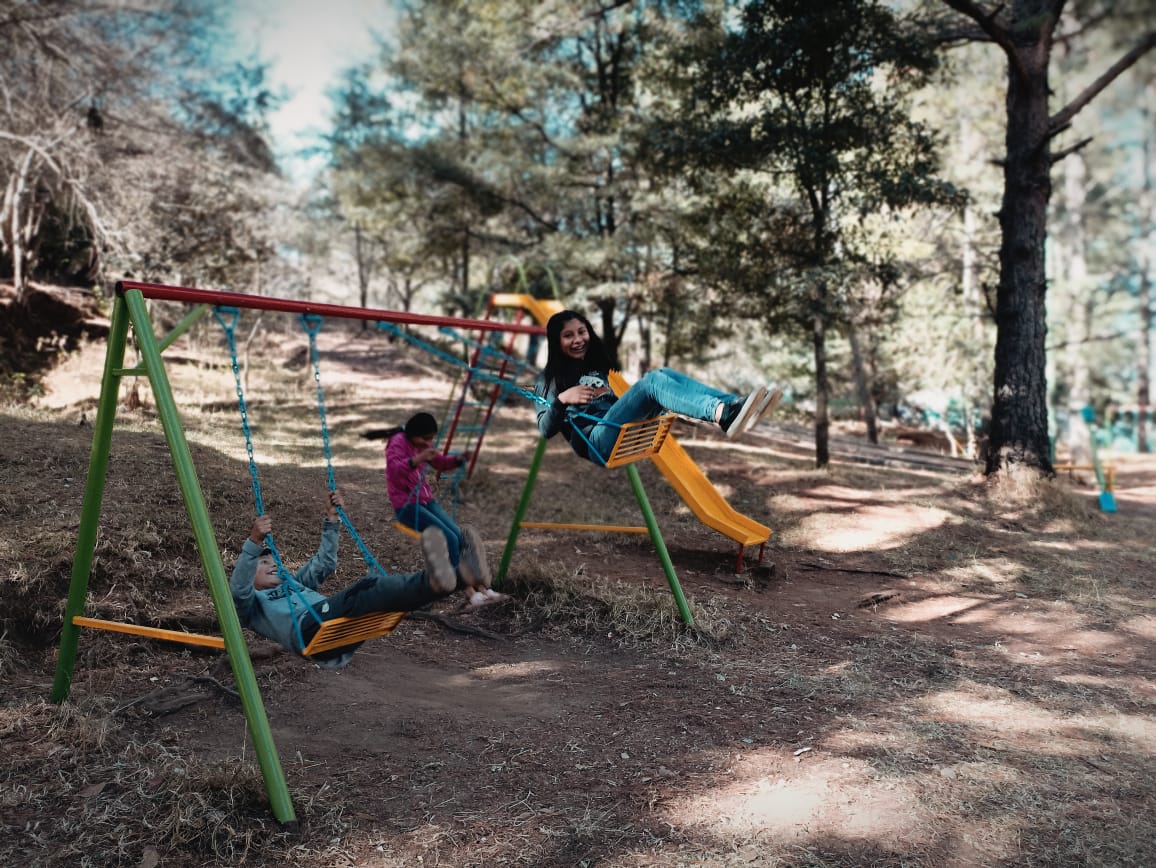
[117,281,546,334]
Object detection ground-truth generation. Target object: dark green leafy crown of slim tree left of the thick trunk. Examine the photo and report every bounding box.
[652,0,961,327]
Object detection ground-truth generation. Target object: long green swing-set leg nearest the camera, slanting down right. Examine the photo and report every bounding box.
[117,289,297,823]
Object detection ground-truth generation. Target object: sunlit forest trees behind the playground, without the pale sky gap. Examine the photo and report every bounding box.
[0,0,1156,473]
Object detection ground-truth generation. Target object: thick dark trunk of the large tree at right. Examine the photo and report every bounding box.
[986,10,1054,475]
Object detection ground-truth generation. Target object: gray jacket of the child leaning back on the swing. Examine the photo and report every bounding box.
[229,519,341,653]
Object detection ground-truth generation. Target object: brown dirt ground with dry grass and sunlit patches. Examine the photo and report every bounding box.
[0,321,1156,868]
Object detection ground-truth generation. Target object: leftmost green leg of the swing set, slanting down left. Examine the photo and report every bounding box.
[51,298,128,703]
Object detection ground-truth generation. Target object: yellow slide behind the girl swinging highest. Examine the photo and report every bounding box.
[492,292,771,546]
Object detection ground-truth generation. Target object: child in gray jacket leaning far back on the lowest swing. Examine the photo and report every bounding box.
[229,491,492,667]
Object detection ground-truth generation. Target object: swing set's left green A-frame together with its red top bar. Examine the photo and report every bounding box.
[51,281,541,824]
